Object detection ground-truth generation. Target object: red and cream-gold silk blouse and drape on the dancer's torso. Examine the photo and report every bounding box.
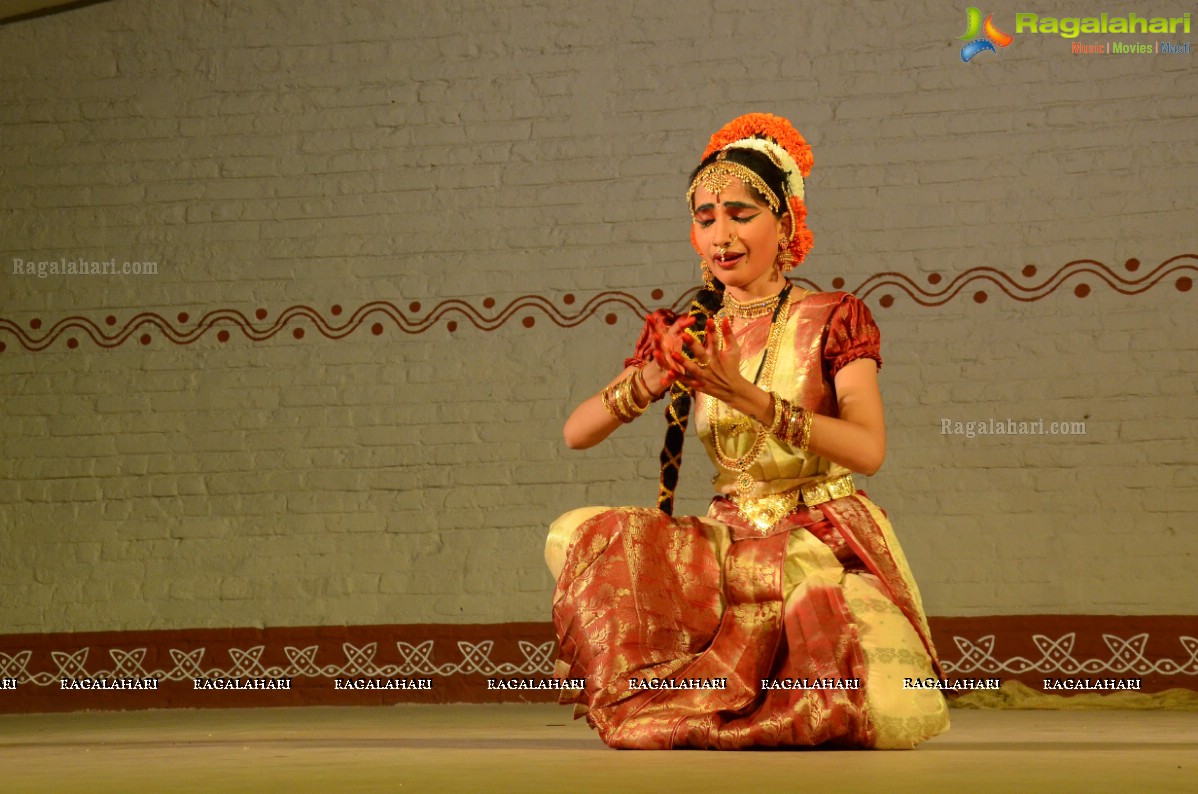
[695,292,882,496]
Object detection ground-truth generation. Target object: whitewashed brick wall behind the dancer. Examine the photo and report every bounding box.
[0,0,1198,634]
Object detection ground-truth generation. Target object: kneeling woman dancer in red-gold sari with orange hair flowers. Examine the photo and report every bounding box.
[545,114,949,750]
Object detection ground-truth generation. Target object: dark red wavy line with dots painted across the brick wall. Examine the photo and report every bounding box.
[0,254,1198,353]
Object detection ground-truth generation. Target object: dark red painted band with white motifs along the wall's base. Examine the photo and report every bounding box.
[0,614,1198,714]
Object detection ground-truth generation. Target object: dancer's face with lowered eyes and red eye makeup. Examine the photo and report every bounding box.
[692,180,786,296]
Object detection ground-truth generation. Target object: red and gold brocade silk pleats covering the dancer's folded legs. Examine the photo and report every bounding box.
[553,497,946,750]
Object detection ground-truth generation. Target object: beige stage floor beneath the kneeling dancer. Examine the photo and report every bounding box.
[0,705,1198,794]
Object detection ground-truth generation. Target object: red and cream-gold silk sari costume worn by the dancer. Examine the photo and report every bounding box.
[546,292,949,750]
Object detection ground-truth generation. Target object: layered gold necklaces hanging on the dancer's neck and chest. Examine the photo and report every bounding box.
[707,285,791,496]
